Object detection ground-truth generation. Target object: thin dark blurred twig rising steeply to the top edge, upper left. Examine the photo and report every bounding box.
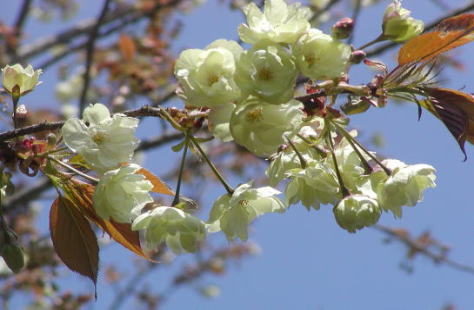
[79,0,113,116]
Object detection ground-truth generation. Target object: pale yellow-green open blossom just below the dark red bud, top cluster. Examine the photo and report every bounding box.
[294,29,351,80]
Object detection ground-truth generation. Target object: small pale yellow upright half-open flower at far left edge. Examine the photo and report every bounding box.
[2,64,42,96]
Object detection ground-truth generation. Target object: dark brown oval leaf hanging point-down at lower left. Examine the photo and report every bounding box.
[49,196,99,285]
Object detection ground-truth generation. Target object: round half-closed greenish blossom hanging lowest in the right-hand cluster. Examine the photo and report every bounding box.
[333,194,382,233]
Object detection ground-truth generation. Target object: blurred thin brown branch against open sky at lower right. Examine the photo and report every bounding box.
[372,225,474,274]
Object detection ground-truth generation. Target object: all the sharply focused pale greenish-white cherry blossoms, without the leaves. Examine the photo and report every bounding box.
[3,0,435,260]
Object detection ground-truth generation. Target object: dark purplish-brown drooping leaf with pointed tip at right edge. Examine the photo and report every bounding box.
[426,87,474,156]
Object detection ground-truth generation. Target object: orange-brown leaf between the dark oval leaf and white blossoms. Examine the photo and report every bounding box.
[66,180,154,261]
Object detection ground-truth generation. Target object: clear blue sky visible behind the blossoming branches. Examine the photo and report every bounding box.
[0,0,474,310]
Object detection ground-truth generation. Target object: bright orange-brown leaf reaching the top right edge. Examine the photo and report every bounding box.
[398,14,474,65]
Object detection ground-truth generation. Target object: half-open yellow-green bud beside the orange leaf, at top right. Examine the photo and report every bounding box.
[382,0,424,42]
